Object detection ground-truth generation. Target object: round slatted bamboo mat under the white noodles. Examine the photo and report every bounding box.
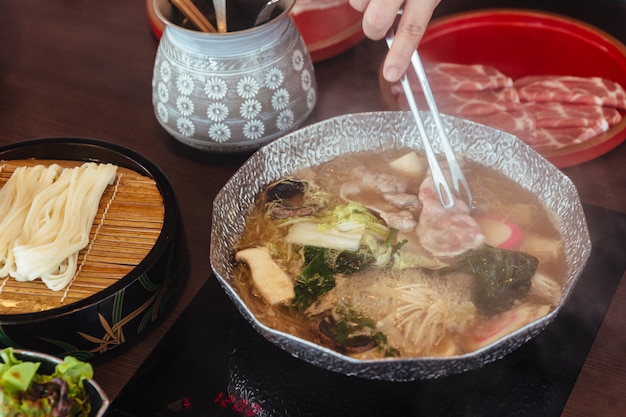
[0,160,165,315]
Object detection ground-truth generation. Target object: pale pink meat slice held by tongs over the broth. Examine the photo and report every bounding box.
[416,177,485,257]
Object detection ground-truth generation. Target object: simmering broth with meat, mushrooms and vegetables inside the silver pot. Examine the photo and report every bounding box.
[235,149,565,358]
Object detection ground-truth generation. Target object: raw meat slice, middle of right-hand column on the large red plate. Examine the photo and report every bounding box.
[523,102,622,128]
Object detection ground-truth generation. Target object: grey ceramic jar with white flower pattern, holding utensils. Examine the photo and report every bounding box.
[152,0,317,152]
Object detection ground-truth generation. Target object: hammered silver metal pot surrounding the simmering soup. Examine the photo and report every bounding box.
[211,112,591,381]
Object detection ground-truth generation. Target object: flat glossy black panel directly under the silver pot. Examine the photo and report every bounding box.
[109,206,626,417]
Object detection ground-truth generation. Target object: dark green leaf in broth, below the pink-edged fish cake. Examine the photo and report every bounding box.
[441,245,539,315]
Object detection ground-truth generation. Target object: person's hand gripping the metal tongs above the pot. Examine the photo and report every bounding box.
[349,0,441,82]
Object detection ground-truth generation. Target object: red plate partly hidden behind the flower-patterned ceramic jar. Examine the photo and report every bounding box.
[146,0,365,62]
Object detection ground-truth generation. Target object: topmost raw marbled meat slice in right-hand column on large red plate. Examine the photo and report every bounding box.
[514,75,626,110]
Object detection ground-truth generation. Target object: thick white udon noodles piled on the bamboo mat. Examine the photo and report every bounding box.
[0,163,117,291]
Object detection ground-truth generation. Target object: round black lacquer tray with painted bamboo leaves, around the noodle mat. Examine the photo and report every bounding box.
[0,138,188,360]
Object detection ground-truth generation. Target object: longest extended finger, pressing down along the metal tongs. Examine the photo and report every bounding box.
[383,0,440,82]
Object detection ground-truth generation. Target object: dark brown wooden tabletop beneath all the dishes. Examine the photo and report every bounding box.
[0,0,626,416]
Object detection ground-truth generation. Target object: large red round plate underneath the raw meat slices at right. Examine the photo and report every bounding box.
[381,9,626,168]
